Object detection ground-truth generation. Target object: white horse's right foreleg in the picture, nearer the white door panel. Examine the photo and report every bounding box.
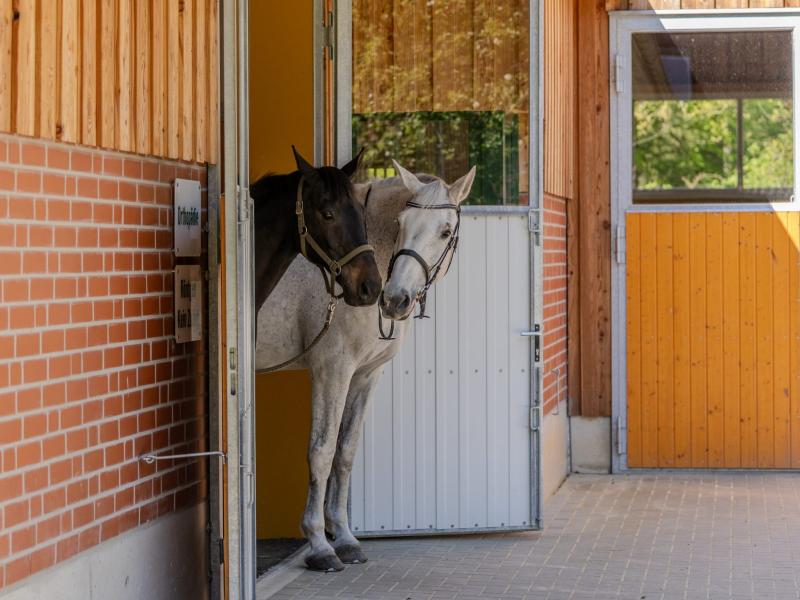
[325,365,383,564]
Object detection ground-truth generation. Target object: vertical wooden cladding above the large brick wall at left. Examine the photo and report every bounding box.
[0,0,219,162]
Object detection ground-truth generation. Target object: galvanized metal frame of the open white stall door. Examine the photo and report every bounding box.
[334,0,544,537]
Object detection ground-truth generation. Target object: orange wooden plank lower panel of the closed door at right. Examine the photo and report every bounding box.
[626,212,800,469]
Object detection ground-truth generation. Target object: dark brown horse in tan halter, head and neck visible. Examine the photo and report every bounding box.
[255,146,381,312]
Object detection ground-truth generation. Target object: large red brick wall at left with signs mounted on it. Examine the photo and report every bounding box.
[0,135,208,589]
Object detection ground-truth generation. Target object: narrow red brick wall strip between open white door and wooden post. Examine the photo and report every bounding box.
[543,194,567,414]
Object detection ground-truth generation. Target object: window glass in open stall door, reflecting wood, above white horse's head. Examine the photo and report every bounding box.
[352,0,529,205]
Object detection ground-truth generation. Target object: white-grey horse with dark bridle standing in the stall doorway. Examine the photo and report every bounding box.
[256,163,475,571]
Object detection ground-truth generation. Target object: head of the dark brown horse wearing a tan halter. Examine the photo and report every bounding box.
[292,146,381,306]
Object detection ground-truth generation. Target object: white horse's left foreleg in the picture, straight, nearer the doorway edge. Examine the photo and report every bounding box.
[302,364,352,571]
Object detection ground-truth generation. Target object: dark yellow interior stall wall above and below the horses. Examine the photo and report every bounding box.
[250,0,314,538]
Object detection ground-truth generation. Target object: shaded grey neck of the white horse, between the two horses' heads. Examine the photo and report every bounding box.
[367,178,411,282]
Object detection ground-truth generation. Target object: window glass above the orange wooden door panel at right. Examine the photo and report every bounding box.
[632,31,794,202]
